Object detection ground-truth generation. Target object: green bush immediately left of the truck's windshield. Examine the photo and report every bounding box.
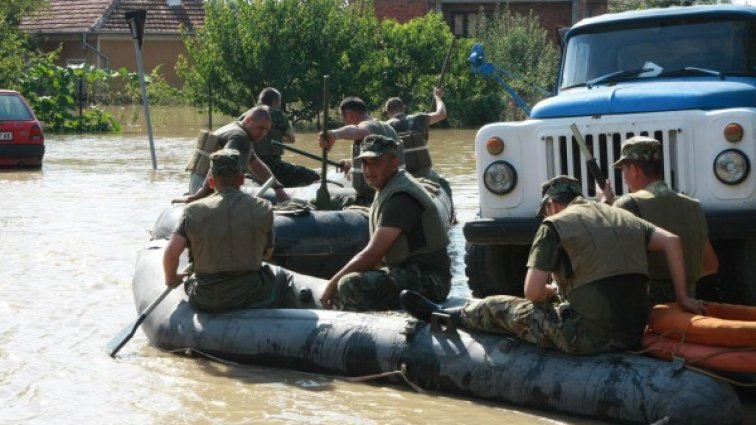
[472,7,558,119]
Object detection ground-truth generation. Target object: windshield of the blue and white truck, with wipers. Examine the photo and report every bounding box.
[560,20,756,89]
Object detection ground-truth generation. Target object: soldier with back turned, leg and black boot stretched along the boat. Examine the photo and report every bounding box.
[400,176,703,354]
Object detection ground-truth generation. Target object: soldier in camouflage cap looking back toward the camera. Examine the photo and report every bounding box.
[321,135,451,311]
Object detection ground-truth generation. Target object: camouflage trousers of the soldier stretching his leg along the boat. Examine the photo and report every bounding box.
[462,295,635,354]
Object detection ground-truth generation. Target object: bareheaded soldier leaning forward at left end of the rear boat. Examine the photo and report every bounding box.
[173,106,289,202]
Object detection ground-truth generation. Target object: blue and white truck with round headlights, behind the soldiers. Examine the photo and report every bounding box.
[464,5,756,304]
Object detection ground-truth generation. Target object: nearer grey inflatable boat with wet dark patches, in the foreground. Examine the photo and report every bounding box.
[133,240,742,425]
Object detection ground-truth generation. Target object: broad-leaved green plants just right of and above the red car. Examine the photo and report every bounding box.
[19,62,120,132]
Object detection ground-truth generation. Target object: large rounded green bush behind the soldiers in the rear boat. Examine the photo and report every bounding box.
[177,0,376,122]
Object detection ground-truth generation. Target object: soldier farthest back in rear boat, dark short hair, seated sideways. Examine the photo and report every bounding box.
[240,87,320,187]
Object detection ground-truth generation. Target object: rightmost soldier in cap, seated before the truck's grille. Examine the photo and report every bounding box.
[603,136,719,306]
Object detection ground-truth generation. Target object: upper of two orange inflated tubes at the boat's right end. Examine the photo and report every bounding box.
[649,303,756,348]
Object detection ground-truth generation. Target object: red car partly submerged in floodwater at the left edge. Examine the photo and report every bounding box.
[0,90,45,168]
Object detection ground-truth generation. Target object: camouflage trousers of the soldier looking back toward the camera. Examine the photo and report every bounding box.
[336,264,451,311]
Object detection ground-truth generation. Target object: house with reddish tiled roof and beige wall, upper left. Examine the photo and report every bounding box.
[20,0,205,87]
